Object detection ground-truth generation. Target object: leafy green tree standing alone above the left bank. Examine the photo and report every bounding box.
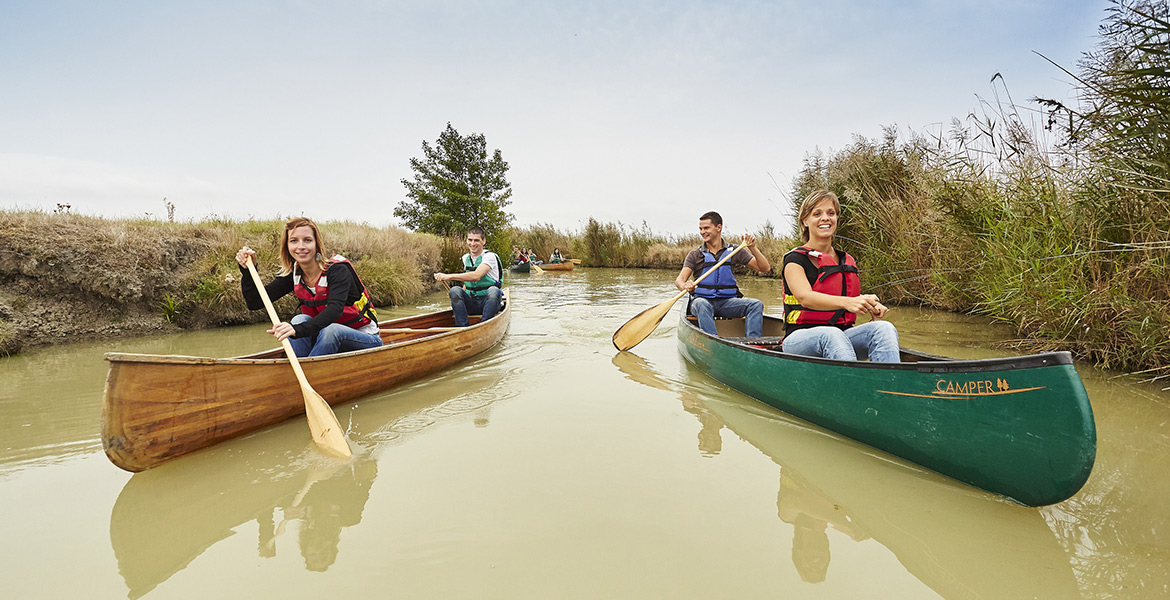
[394,123,512,254]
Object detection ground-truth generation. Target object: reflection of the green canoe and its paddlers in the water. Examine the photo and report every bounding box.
[613,352,1080,600]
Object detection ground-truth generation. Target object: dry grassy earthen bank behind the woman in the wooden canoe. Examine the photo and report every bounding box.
[0,212,441,353]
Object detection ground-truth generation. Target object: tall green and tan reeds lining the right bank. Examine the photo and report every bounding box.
[794,0,1170,374]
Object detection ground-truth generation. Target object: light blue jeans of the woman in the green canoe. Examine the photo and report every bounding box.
[783,320,901,363]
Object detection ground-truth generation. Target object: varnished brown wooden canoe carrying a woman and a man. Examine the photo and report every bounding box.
[102,292,511,471]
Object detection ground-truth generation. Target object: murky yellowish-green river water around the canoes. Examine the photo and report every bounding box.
[0,269,1170,600]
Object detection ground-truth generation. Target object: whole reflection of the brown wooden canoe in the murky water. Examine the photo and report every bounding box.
[110,359,510,599]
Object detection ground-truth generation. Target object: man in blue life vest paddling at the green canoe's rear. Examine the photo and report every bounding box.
[674,211,772,338]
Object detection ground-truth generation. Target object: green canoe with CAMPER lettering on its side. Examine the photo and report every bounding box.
[677,316,1096,506]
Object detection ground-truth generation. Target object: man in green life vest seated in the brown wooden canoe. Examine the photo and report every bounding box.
[435,227,504,327]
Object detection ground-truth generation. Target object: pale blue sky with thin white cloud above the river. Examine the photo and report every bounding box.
[0,0,1109,234]
